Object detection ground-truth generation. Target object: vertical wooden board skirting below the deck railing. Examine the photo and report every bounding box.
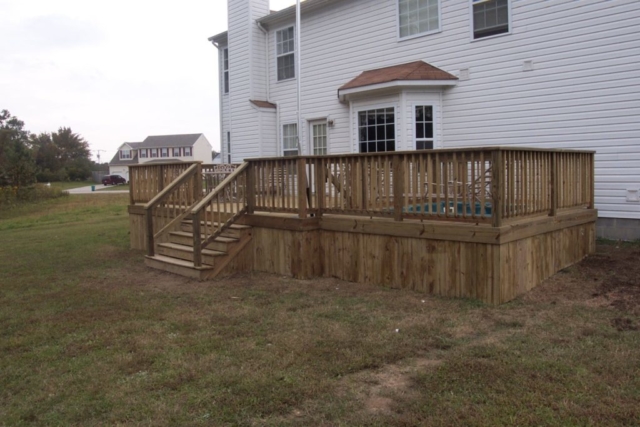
[130,209,597,304]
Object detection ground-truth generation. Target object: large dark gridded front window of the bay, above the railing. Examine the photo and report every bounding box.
[358,107,396,153]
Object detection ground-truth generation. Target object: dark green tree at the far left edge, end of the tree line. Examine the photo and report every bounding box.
[0,110,36,187]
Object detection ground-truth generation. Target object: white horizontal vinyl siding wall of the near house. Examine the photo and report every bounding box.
[219,0,640,226]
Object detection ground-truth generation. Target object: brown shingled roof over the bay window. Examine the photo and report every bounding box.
[340,61,458,90]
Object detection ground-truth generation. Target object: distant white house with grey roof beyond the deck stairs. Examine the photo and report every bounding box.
[109,133,212,181]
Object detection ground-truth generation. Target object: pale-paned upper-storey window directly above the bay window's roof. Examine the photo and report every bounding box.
[398,0,440,38]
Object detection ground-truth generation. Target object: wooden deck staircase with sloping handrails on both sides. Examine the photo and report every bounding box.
[145,164,251,280]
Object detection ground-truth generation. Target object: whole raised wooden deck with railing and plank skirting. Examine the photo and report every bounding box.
[129,147,597,304]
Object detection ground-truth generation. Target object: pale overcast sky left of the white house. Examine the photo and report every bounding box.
[0,0,295,161]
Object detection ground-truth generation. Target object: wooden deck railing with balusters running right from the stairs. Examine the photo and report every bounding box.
[248,148,594,226]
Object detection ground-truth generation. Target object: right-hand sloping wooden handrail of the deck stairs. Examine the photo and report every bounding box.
[191,162,249,267]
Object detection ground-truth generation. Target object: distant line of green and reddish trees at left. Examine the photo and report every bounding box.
[0,110,100,187]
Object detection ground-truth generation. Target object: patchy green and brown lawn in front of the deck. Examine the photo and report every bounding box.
[0,194,640,426]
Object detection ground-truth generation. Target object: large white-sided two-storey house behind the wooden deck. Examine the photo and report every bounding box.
[209,0,640,238]
